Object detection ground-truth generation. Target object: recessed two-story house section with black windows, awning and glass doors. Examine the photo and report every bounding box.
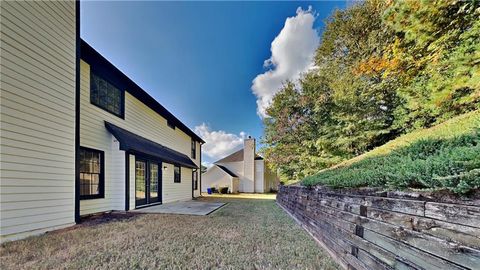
[79,40,203,215]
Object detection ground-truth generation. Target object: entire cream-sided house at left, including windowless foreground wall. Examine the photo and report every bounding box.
[0,1,204,241]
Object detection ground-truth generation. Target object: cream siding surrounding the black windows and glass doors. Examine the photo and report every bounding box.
[80,60,200,214]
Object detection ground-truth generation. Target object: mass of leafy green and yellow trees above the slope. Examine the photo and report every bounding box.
[263,0,480,184]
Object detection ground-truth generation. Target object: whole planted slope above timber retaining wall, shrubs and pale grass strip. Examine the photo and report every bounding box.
[302,110,480,194]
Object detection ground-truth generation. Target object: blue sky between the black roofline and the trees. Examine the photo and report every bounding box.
[81,1,346,165]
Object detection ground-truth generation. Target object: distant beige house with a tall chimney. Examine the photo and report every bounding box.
[201,137,280,193]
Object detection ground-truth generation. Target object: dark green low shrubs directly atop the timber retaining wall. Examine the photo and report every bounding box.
[303,131,480,194]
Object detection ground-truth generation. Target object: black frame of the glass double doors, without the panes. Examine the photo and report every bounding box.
[133,154,163,208]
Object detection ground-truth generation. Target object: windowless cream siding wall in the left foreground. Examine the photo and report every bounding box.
[0,1,76,241]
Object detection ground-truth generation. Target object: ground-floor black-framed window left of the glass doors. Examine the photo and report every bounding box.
[79,147,105,199]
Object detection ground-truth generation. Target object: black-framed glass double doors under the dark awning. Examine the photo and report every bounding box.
[135,158,161,206]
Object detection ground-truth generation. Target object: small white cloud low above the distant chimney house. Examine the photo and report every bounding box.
[195,123,247,160]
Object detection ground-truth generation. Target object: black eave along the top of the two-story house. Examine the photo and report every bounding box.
[80,39,205,143]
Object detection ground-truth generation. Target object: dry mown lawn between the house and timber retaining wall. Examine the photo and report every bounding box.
[0,197,338,269]
